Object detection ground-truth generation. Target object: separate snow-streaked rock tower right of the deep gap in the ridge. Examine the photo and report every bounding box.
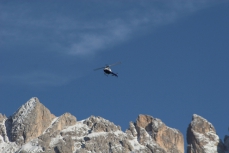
[187,114,227,153]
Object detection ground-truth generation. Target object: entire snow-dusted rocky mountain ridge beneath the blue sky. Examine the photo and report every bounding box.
[0,97,229,153]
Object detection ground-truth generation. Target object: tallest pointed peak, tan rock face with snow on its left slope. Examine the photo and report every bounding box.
[10,98,55,145]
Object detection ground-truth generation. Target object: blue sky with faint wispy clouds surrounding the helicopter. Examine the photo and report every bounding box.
[0,0,229,149]
